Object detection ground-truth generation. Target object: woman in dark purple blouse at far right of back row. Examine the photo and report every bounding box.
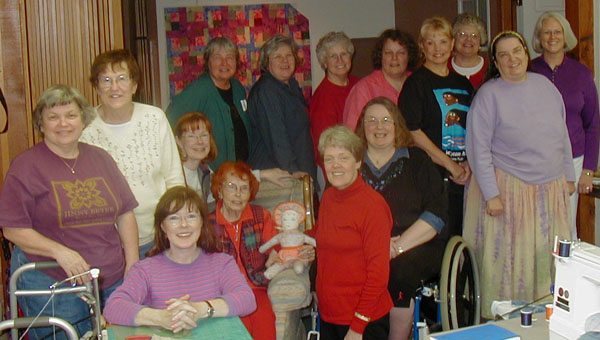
[531,12,600,238]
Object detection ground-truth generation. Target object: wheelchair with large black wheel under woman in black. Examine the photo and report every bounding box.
[413,236,481,340]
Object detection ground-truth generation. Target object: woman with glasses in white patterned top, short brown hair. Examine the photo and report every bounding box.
[80,50,185,259]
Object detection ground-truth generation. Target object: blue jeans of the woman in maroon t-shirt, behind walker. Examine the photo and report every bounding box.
[10,247,123,339]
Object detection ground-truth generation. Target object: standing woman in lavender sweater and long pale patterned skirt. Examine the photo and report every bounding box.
[463,31,575,318]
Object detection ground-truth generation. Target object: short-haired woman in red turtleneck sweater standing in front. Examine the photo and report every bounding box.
[316,126,392,339]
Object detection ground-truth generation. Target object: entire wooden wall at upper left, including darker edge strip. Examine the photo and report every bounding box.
[0,0,123,183]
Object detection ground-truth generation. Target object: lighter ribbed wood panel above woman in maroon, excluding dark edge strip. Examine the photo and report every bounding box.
[24,0,123,115]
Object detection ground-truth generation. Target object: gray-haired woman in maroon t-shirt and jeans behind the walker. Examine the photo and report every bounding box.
[0,85,138,339]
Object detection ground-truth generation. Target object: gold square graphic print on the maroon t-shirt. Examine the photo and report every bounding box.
[52,177,119,228]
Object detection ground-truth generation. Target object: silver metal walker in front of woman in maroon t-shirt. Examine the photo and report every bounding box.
[0,261,108,340]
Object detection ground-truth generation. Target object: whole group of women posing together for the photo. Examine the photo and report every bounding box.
[0,8,600,339]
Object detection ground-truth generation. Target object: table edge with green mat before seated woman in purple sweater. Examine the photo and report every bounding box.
[108,316,252,340]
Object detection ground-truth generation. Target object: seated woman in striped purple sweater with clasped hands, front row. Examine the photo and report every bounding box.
[104,186,256,333]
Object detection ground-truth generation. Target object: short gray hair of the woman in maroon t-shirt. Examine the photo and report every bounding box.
[33,84,96,134]
